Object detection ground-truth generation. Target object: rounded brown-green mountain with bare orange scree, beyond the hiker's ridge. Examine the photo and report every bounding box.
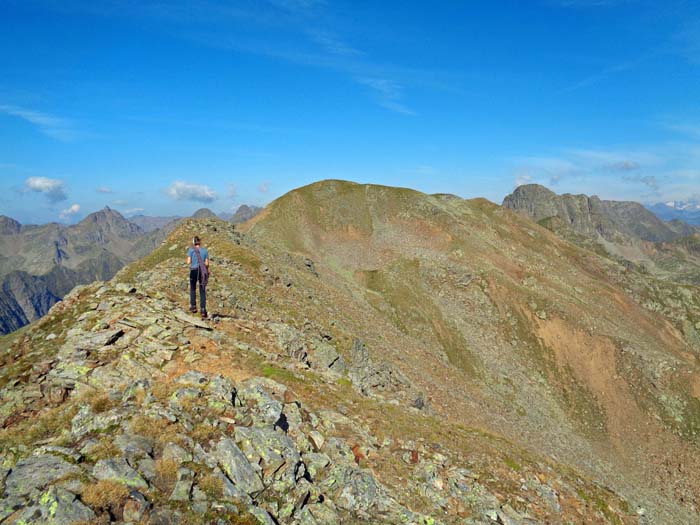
[249,181,700,520]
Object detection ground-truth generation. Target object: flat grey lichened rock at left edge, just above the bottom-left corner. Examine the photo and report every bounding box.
[5,454,82,497]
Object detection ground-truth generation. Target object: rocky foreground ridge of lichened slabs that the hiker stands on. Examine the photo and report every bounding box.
[0,215,645,525]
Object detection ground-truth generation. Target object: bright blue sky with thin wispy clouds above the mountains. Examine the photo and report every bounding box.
[0,0,700,223]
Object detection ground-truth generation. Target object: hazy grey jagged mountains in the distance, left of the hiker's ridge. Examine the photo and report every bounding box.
[0,205,262,334]
